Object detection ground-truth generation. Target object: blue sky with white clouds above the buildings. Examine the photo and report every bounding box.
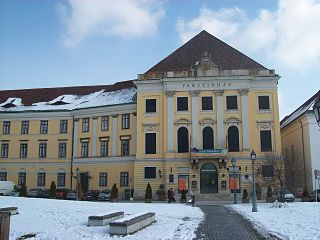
[0,0,320,118]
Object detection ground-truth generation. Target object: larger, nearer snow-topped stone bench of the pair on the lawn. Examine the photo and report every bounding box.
[109,212,156,235]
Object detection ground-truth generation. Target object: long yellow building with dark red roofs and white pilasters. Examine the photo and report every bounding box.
[0,31,281,199]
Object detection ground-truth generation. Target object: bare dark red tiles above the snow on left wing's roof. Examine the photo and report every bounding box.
[0,80,135,106]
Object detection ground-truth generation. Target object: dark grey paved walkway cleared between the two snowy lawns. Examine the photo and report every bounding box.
[195,205,266,240]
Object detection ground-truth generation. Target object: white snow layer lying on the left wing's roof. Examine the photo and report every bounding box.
[0,87,137,112]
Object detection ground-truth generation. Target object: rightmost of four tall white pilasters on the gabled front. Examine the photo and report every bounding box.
[239,89,250,150]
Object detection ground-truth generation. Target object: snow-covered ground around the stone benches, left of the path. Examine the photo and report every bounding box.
[0,197,204,240]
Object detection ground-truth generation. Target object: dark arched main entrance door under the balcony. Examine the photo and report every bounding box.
[200,163,218,193]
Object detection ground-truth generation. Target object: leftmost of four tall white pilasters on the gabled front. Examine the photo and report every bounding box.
[166,92,174,152]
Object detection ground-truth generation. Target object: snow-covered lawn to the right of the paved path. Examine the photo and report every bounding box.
[229,202,320,240]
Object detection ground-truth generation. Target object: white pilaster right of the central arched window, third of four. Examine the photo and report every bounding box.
[215,90,226,149]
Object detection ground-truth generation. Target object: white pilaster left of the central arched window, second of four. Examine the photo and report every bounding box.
[190,91,199,149]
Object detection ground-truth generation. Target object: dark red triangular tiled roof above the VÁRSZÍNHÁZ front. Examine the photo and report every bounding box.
[145,31,267,74]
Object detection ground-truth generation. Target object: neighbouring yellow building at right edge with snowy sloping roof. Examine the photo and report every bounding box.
[281,91,320,193]
